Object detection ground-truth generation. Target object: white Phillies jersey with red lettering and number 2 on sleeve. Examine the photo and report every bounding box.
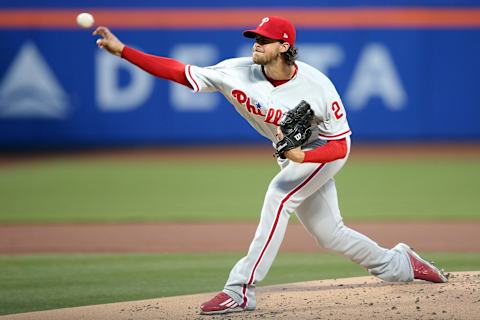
[185,58,351,143]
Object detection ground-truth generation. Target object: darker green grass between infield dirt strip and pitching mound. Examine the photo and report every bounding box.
[0,253,480,314]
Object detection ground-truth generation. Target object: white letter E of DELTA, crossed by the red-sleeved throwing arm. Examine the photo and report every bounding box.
[170,44,219,111]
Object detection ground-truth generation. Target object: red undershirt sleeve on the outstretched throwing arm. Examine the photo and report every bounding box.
[122,46,192,89]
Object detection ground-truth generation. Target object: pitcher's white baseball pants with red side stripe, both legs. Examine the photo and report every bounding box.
[223,141,413,309]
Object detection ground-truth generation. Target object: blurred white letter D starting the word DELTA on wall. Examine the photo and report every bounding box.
[95,50,155,111]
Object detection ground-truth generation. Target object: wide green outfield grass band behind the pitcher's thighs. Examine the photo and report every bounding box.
[0,159,480,223]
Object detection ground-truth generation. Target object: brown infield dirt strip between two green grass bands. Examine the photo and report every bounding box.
[0,221,480,254]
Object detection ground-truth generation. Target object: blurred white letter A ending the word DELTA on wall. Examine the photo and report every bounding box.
[345,43,407,111]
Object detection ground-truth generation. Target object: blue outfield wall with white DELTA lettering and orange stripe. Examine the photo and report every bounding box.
[0,0,480,149]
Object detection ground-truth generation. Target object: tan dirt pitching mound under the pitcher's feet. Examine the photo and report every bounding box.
[0,271,480,320]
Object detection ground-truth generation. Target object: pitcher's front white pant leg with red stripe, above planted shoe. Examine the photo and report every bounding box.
[216,160,346,309]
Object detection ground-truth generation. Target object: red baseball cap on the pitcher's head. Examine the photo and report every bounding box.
[243,16,295,46]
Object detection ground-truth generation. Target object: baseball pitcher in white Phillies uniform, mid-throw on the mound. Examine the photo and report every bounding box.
[94,16,447,314]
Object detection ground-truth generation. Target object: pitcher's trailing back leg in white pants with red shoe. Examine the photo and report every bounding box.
[297,179,446,282]
